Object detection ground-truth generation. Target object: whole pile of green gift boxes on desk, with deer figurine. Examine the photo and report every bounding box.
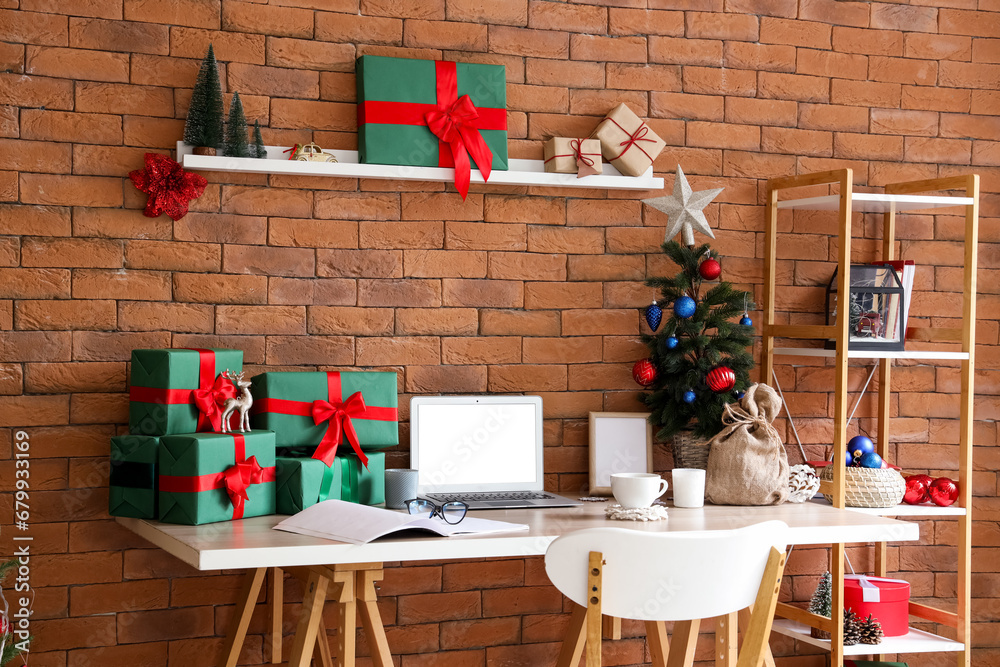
[109,349,399,524]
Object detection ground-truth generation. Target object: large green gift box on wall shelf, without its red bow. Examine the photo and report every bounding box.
[357,56,507,170]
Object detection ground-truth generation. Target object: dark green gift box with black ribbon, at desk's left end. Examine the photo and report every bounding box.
[108,435,160,519]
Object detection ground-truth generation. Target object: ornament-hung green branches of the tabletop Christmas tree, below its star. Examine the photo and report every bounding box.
[640,241,754,440]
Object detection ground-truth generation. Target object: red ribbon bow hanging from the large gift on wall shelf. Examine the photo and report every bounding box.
[424,95,493,199]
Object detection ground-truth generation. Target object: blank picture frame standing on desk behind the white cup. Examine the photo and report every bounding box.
[590,412,653,496]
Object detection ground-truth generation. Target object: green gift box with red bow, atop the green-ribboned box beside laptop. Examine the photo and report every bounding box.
[250,371,399,463]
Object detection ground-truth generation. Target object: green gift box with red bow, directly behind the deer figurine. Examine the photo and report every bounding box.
[128,349,243,435]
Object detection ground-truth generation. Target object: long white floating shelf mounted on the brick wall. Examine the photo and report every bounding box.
[177,141,663,190]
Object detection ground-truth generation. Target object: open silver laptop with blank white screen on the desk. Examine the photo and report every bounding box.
[410,395,582,509]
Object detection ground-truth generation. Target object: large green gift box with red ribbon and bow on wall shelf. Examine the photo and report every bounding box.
[357,56,507,198]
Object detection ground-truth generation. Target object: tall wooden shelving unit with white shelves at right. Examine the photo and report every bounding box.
[760,169,979,667]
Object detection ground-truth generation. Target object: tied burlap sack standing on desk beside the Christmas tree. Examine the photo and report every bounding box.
[705,384,788,505]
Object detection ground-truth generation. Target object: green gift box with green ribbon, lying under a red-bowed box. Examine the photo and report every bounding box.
[275,452,385,514]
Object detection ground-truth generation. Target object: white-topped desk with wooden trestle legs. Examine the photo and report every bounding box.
[117,503,919,667]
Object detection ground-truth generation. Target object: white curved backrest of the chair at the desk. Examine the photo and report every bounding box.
[545,521,788,621]
